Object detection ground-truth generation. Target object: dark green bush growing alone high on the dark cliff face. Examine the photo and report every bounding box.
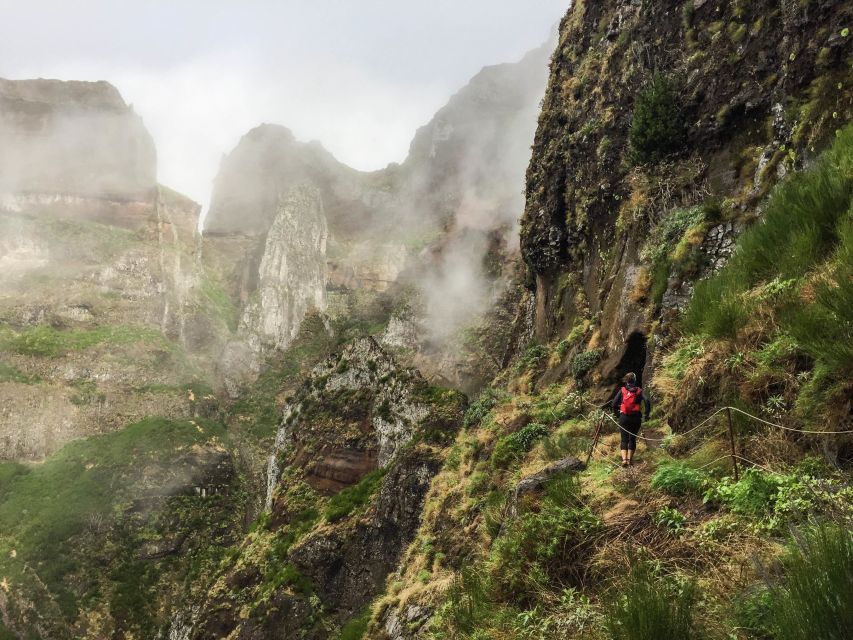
[628,73,685,163]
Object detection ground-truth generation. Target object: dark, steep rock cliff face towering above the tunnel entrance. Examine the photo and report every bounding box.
[521,0,851,391]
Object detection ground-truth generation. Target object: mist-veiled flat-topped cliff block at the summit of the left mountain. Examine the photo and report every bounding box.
[0,78,157,200]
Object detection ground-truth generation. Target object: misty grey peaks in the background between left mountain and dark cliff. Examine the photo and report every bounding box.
[203,47,548,393]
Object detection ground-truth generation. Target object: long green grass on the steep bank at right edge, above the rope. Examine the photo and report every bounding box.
[683,125,853,344]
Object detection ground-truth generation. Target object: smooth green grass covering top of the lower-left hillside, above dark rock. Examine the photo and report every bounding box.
[0,418,230,614]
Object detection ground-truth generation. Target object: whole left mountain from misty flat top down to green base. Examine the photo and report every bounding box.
[0,80,243,639]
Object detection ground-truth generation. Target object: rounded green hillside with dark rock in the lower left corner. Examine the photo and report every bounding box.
[0,418,243,638]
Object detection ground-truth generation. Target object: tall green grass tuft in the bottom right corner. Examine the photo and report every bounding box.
[771,525,853,640]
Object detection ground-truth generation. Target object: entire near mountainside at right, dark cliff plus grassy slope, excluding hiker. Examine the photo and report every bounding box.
[326,2,853,639]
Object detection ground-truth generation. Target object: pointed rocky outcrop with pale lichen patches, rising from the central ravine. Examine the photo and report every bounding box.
[190,338,464,639]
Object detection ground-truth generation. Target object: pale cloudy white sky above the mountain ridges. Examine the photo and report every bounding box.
[0,0,569,205]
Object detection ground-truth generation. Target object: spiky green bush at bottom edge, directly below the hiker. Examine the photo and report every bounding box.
[606,563,704,640]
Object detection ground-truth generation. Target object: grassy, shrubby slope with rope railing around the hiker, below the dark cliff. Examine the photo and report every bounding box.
[366,126,853,640]
